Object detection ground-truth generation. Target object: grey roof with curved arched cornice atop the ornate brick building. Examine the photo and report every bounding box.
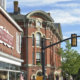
[9,10,62,39]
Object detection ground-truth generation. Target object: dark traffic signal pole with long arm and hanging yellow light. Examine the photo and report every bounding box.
[41,34,80,80]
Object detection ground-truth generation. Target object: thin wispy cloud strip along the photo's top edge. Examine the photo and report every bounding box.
[7,0,72,7]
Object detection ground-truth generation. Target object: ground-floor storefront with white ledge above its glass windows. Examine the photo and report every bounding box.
[0,52,23,80]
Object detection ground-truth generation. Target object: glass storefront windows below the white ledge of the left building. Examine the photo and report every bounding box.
[0,62,21,80]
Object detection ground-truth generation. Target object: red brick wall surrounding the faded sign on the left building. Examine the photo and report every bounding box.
[0,13,21,58]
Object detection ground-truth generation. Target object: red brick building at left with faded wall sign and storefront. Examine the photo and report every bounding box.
[0,7,23,80]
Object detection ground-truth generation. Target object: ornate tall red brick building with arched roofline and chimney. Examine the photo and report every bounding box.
[10,1,62,80]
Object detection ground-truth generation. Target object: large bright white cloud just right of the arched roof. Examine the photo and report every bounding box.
[48,9,80,24]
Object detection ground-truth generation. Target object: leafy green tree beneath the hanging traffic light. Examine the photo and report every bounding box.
[58,41,80,78]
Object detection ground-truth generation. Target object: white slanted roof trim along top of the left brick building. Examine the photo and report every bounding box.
[0,7,23,32]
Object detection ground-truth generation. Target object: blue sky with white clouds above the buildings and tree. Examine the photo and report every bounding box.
[7,0,80,53]
